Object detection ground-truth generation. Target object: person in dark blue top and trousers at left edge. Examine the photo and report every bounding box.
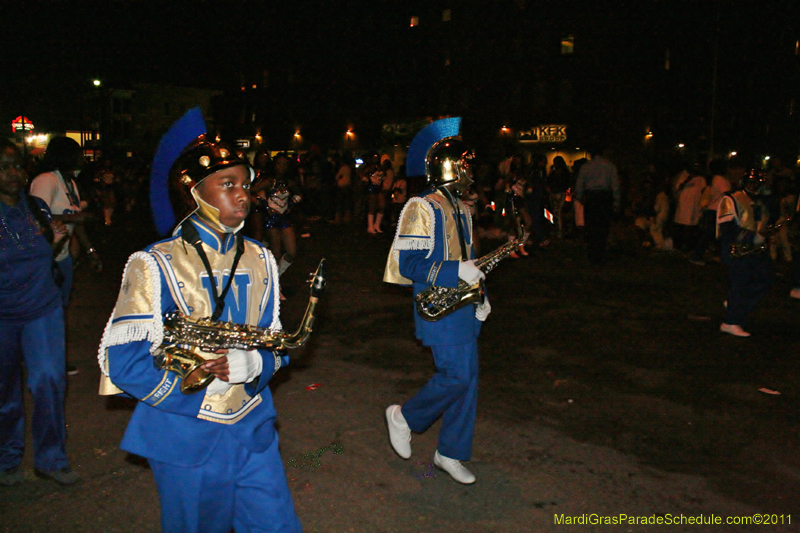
[0,139,80,486]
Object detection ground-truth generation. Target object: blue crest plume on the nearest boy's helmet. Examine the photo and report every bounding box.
[150,107,206,235]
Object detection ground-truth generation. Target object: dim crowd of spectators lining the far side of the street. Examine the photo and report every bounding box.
[15,139,798,265]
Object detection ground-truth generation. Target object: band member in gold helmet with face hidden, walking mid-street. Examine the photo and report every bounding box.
[383,118,491,484]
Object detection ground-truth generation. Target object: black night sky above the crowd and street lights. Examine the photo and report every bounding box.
[0,0,800,156]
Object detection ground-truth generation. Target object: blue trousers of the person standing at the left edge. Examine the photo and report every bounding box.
[0,307,69,470]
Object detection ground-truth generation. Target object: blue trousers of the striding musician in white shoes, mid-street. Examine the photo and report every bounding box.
[402,339,478,461]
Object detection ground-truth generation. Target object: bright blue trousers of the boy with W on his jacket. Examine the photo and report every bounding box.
[150,428,302,533]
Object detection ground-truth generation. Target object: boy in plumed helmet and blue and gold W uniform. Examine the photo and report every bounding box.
[98,108,301,533]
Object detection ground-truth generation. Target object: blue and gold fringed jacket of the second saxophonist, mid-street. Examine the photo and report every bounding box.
[383,189,481,346]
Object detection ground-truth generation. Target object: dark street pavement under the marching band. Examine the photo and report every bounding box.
[0,218,800,533]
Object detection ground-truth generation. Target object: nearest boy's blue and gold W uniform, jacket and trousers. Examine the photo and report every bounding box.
[98,110,301,533]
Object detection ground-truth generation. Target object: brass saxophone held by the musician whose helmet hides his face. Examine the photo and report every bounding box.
[414,193,529,322]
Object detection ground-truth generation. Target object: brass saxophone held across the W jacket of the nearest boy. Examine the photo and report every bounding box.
[154,259,326,394]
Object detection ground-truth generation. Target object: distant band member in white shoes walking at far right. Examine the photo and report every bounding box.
[717,169,774,337]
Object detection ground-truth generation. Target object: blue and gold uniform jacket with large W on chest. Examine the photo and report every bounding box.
[98,216,288,466]
